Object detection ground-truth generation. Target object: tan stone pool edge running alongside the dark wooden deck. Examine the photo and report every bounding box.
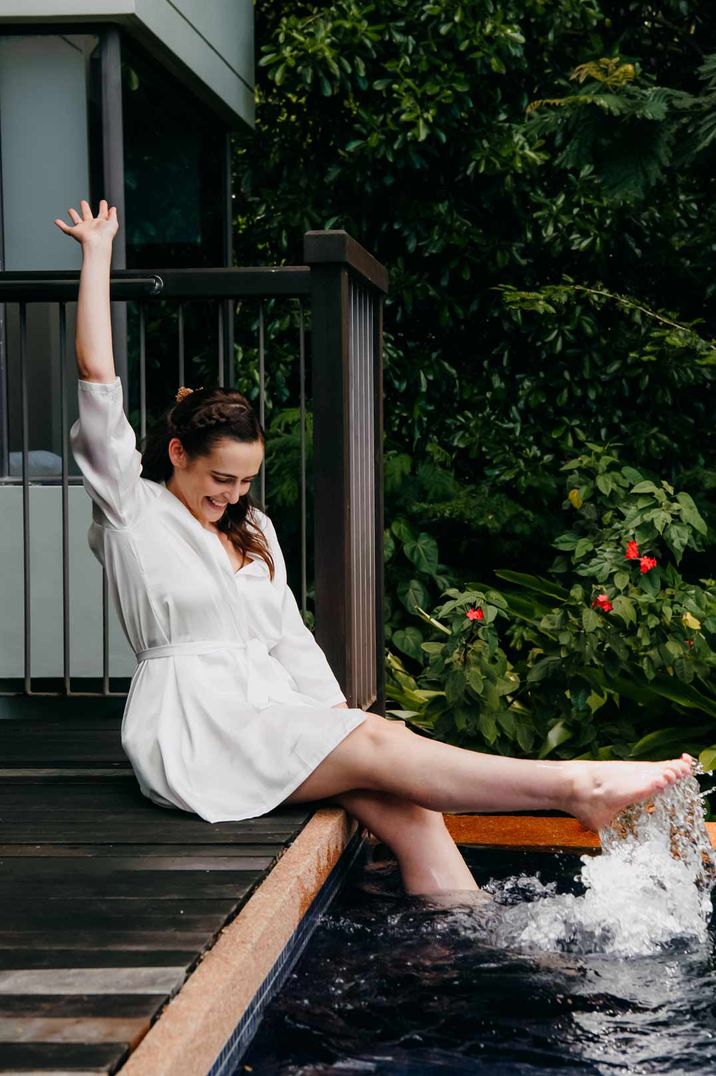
[117,807,362,1076]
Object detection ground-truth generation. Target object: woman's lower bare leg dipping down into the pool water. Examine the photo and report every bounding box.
[332,789,478,894]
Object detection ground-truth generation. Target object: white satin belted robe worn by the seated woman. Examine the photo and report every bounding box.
[70,378,366,822]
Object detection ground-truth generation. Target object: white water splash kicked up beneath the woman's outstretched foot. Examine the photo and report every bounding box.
[486,777,716,957]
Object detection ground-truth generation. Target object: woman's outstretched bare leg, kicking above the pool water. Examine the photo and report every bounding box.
[286,714,691,830]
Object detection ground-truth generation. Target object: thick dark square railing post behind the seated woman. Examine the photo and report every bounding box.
[304,231,388,712]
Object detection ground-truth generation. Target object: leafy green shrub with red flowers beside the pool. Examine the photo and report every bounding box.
[389,444,716,758]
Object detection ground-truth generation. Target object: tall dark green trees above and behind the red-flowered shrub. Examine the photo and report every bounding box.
[235,0,716,589]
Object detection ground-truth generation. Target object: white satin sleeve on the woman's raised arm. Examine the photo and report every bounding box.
[70,377,151,527]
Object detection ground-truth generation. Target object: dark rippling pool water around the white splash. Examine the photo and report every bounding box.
[237,846,716,1076]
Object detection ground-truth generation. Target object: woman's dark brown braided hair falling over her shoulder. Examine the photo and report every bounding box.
[142,388,276,579]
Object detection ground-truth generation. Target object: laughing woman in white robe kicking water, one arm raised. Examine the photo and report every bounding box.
[55,200,692,894]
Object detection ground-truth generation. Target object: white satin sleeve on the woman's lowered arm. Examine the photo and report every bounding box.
[261,515,346,706]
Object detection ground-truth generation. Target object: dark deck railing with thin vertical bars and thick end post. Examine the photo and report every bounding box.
[0,231,387,710]
